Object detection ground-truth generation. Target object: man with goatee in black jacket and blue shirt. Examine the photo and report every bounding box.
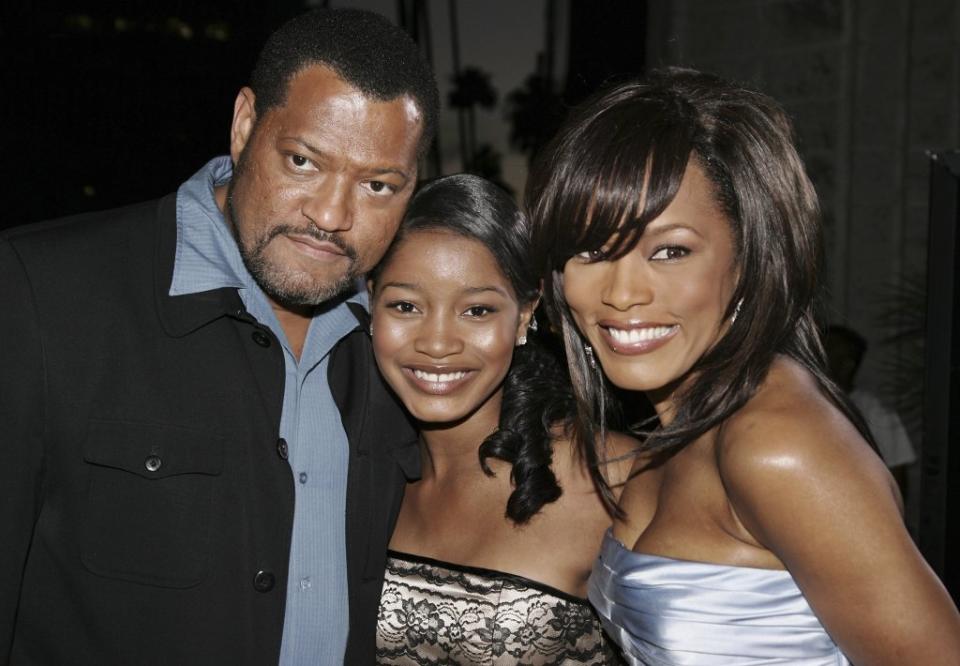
[0,10,437,666]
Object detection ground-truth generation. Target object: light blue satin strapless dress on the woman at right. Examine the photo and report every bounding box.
[588,531,850,666]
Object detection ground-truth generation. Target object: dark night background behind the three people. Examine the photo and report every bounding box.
[0,0,960,595]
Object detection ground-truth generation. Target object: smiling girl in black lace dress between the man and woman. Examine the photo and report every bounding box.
[369,175,632,664]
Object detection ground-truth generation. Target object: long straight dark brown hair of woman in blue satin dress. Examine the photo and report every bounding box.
[526,69,872,502]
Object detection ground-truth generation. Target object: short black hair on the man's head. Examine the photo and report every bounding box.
[250,9,439,154]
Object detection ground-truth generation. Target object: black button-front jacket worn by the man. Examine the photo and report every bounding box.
[0,195,419,666]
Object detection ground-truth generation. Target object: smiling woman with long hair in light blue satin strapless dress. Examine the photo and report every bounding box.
[527,70,960,665]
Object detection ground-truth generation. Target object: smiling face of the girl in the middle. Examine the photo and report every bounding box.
[371,230,529,429]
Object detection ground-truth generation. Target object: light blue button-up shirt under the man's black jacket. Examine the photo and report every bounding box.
[170,157,367,666]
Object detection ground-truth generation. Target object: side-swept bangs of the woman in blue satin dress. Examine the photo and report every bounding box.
[527,84,693,274]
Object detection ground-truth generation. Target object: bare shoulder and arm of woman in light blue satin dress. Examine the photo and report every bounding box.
[716,359,960,663]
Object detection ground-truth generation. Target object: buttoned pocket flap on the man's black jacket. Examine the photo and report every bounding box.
[83,419,223,479]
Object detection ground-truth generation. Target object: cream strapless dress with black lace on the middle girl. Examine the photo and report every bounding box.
[377,551,622,666]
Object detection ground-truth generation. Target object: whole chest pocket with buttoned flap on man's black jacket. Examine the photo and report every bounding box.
[81,420,223,588]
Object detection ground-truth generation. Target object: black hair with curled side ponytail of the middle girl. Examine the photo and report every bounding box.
[370,174,575,523]
